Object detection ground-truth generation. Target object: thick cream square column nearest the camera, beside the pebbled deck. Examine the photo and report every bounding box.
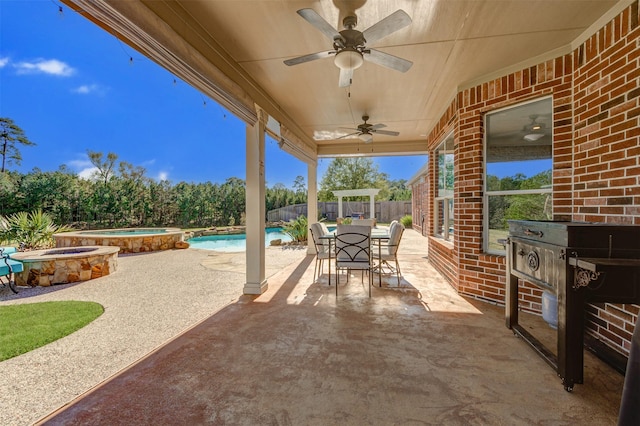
[243,111,268,294]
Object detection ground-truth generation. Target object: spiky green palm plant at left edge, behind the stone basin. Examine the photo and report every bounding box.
[0,210,73,249]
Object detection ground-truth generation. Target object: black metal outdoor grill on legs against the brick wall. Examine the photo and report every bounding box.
[505,220,640,391]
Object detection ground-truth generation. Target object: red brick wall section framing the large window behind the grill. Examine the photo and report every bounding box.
[427,55,572,302]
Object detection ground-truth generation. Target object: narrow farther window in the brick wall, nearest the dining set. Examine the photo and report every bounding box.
[433,135,454,240]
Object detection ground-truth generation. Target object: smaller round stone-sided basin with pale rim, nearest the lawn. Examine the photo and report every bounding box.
[11,246,120,287]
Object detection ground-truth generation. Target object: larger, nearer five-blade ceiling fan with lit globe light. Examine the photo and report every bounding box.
[284,9,413,87]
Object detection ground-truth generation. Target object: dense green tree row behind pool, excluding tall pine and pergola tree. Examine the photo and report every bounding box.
[0,163,306,228]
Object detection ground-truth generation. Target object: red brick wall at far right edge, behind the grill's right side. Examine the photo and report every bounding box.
[572,3,640,354]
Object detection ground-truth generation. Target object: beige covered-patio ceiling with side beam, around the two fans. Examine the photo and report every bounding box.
[63,0,630,160]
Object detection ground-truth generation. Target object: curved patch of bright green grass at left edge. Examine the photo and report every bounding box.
[0,301,104,361]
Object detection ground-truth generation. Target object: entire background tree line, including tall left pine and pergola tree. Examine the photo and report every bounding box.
[0,118,411,229]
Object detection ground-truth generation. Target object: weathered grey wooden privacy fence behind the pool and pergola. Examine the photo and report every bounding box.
[267,201,411,223]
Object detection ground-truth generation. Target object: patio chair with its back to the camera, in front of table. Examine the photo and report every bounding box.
[335,225,372,297]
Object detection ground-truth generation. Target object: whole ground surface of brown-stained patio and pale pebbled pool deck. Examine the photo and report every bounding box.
[0,230,623,425]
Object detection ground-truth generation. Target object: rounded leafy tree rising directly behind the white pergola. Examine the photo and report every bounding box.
[318,157,389,201]
